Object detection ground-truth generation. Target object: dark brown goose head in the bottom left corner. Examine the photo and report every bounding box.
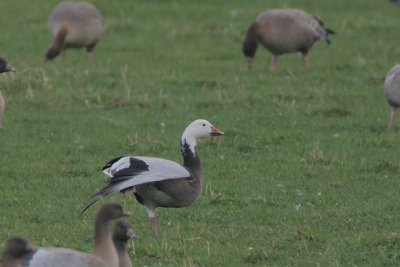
[1,236,36,267]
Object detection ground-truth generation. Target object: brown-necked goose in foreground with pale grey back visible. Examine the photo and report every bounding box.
[15,202,130,267]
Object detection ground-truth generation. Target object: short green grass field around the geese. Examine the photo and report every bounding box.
[0,0,400,266]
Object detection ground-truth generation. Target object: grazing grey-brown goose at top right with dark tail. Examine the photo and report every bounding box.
[242,9,334,72]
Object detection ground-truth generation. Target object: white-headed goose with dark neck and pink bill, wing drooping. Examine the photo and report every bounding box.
[82,120,224,235]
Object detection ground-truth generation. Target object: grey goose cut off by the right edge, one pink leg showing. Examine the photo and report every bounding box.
[384,64,400,130]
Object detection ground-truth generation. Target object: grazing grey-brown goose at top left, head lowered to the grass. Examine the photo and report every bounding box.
[45,2,103,60]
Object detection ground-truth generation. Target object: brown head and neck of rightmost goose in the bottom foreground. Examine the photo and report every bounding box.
[113,220,136,267]
